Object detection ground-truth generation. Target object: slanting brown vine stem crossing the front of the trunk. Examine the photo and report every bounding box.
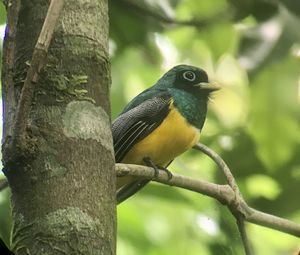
[12,0,64,148]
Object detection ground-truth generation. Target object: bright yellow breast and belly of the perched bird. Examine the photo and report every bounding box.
[122,104,200,167]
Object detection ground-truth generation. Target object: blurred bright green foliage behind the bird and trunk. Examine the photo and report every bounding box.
[0,0,300,255]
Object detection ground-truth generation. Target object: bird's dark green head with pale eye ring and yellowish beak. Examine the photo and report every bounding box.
[155,65,220,95]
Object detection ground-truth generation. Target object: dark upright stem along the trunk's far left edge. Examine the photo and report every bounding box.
[2,0,21,139]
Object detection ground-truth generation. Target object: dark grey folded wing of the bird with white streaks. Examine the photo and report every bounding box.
[112,94,171,162]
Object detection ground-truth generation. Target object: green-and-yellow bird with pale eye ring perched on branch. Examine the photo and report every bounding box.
[112,65,219,203]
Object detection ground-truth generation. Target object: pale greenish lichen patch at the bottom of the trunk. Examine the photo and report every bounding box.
[13,207,110,254]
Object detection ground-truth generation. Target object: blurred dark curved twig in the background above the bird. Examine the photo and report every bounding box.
[121,0,228,28]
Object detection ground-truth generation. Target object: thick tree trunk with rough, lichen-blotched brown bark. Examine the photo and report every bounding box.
[2,0,116,255]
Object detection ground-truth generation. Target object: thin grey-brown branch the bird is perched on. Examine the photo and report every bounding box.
[116,164,300,237]
